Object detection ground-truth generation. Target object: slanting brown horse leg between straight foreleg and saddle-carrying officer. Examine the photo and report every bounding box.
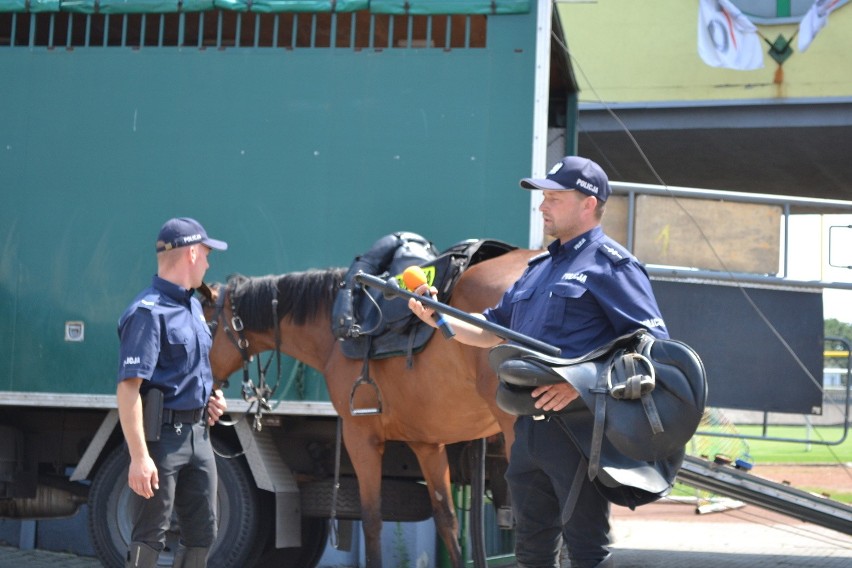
[408,442,463,568]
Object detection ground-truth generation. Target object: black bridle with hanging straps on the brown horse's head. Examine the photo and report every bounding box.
[207,284,281,432]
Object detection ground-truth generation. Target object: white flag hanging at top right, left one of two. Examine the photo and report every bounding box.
[698,0,763,71]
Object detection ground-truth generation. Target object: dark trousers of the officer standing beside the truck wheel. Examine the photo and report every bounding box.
[129,423,217,550]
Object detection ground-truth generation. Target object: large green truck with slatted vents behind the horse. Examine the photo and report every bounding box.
[0,0,551,567]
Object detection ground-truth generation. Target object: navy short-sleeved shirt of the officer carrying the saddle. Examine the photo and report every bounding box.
[483,226,669,358]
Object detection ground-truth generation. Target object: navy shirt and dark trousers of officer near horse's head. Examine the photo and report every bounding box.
[118,276,217,560]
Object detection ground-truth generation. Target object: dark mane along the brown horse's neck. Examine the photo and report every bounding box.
[228,268,346,331]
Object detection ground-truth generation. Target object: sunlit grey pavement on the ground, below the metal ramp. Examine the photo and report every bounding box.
[0,500,852,568]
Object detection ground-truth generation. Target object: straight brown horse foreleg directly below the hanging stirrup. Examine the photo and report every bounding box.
[343,416,385,568]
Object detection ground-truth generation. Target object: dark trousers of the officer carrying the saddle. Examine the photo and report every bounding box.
[506,416,609,568]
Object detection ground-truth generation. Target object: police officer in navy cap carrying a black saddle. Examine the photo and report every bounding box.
[409,156,668,568]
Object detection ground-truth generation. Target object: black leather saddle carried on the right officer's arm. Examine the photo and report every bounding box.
[489,330,707,508]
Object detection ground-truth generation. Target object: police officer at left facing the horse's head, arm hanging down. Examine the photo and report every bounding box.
[116,218,228,568]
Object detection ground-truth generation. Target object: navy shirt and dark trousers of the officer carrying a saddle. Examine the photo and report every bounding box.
[483,226,668,568]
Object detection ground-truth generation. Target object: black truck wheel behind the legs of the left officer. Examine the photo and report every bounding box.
[89,442,266,568]
